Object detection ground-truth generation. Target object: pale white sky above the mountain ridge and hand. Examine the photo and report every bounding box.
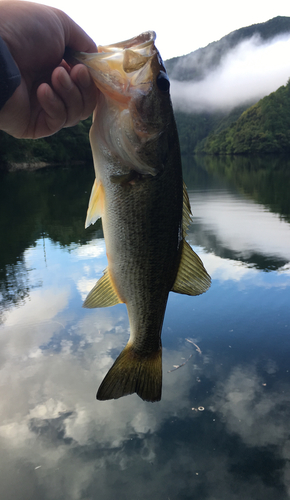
[31,0,290,60]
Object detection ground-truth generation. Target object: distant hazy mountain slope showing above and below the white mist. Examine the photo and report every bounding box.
[165,16,290,155]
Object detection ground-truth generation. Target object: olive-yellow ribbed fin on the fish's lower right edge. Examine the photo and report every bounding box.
[172,240,211,295]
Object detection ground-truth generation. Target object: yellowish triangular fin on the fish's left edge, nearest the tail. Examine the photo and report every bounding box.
[83,269,121,309]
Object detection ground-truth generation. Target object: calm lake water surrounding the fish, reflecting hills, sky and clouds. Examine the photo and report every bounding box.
[0,157,290,500]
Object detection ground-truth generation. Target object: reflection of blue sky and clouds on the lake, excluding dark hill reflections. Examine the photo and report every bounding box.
[0,182,290,500]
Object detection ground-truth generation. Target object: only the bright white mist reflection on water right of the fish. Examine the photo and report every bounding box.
[188,191,290,264]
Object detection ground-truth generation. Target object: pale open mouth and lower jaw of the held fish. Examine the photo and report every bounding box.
[74,31,158,104]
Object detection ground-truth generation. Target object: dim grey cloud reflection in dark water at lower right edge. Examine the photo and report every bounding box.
[211,360,290,447]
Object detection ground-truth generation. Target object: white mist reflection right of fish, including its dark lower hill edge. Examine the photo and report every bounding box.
[189,190,290,270]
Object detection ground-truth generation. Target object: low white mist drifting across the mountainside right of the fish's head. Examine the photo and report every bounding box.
[171,35,290,113]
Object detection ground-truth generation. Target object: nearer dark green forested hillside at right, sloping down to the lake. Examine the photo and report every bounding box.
[196,80,290,155]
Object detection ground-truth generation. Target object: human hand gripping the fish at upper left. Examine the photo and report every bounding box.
[0,0,97,139]
